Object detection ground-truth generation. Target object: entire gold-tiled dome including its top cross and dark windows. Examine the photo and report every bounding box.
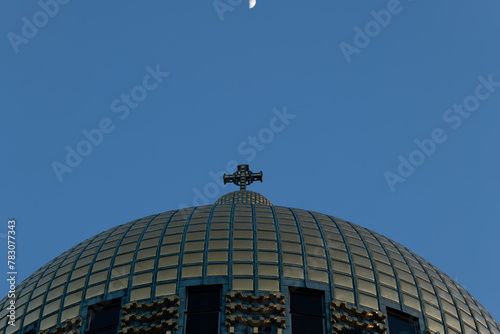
[0,165,500,334]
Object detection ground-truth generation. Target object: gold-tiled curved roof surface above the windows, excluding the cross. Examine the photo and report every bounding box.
[0,197,500,333]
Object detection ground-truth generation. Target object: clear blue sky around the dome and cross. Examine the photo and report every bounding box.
[0,0,500,320]
